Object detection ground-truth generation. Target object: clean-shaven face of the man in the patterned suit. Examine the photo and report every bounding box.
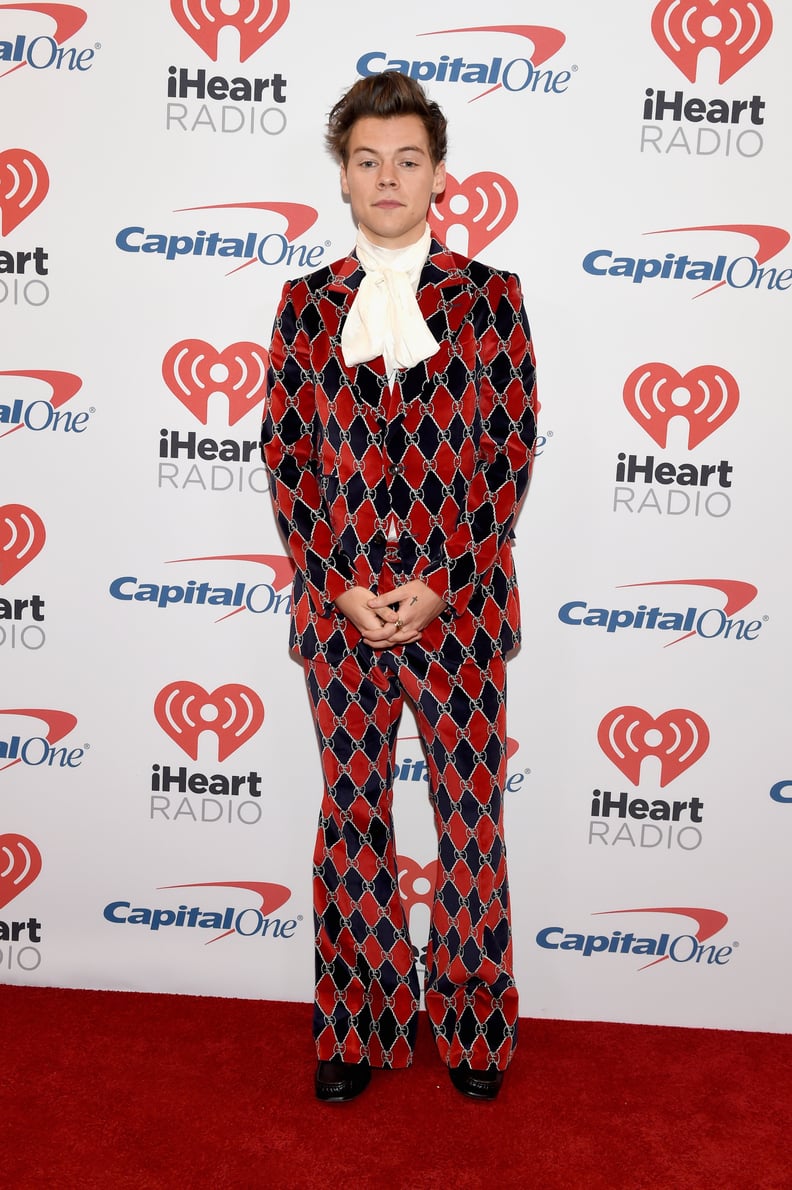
[341,115,446,248]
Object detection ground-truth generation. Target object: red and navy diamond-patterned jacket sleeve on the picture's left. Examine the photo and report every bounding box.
[262,282,356,615]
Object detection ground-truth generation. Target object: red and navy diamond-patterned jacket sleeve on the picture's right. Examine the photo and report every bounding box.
[416,274,538,615]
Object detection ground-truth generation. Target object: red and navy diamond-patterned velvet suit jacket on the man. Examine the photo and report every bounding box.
[262,239,535,669]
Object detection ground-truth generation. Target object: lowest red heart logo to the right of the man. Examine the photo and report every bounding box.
[597,707,710,789]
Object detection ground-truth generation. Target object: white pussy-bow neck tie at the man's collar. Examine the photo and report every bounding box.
[341,224,440,380]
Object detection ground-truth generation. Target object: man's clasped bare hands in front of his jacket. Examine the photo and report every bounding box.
[335,578,446,649]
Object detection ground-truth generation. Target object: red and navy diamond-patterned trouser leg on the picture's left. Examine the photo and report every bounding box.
[300,655,420,1067]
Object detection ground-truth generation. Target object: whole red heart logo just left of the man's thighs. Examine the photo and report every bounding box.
[155,682,264,760]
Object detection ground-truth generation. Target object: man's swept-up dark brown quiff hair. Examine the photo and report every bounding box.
[326,70,447,165]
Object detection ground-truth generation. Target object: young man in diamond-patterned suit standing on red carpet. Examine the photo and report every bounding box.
[263,71,535,1102]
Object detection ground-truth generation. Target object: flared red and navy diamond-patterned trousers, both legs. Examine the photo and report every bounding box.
[303,644,517,1070]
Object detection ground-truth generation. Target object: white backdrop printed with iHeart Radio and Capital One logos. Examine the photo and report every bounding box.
[0,0,792,1032]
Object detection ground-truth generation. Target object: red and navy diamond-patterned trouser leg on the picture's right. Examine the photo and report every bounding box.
[400,657,517,1070]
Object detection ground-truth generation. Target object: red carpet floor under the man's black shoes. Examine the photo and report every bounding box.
[0,985,792,1190]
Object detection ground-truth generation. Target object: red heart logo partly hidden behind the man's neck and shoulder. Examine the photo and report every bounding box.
[428,171,520,256]
